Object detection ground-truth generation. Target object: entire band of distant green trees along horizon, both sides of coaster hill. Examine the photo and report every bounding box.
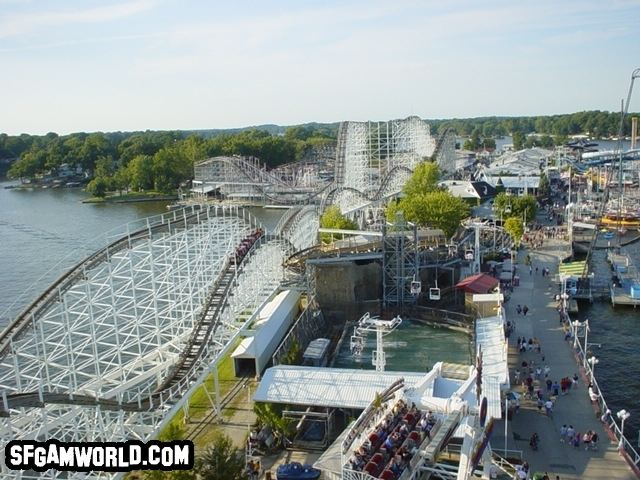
[0,110,638,192]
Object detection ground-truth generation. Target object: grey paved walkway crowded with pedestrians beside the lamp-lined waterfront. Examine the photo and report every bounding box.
[496,240,637,480]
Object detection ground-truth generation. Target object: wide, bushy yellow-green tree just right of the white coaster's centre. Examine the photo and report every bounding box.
[386,191,471,238]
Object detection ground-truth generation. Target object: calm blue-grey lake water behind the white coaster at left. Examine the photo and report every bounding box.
[0,182,284,328]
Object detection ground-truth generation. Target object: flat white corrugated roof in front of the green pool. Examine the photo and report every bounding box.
[253,365,425,409]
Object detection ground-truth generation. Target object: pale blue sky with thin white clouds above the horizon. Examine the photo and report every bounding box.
[0,0,640,134]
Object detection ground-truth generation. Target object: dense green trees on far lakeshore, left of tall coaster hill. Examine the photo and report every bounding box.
[0,126,335,196]
